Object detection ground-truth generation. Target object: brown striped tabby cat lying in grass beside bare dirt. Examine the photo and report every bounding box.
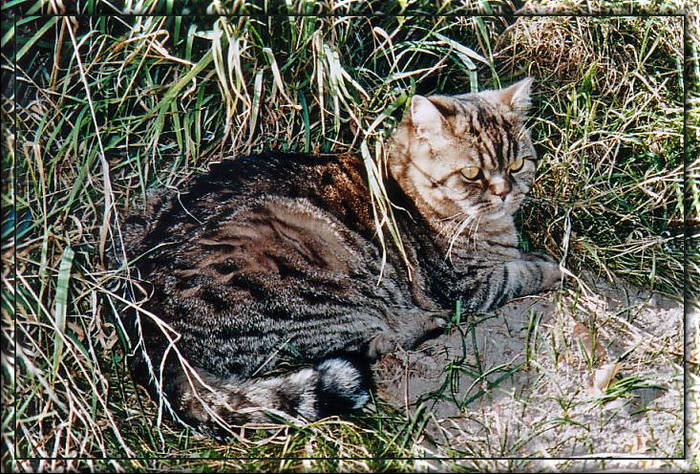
[123,78,561,438]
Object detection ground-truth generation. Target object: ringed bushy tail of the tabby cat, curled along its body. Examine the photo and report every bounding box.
[165,357,371,438]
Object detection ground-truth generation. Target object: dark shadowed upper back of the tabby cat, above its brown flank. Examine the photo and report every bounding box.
[125,152,372,257]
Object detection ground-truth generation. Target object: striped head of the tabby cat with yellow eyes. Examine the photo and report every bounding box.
[388,78,535,230]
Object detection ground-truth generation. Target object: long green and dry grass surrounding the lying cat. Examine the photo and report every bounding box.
[1,0,700,471]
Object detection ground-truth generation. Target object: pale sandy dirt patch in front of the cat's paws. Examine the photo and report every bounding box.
[375,278,684,457]
